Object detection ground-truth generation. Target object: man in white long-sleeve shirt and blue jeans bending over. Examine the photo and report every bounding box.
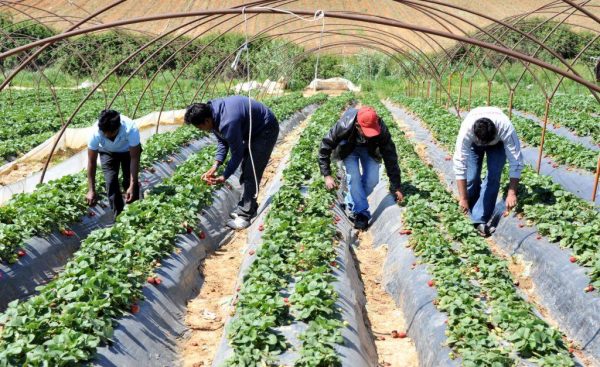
[454,107,523,235]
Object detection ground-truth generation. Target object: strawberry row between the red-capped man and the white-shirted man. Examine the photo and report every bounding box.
[364,98,573,366]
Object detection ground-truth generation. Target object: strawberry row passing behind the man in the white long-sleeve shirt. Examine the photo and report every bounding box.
[396,98,600,291]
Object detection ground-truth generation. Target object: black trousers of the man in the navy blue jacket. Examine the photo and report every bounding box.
[235,121,279,220]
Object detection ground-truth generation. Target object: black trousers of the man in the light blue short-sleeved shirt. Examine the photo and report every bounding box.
[100,152,140,218]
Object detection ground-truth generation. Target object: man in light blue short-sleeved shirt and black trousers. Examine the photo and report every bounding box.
[86,110,142,218]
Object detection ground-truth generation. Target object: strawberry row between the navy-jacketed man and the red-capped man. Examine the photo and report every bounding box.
[227,95,353,366]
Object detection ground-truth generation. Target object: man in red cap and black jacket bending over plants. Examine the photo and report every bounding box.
[319,107,404,230]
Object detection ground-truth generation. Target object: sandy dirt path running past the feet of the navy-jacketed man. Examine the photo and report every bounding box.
[180,118,309,367]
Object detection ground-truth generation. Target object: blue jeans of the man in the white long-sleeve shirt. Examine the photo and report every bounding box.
[467,142,506,224]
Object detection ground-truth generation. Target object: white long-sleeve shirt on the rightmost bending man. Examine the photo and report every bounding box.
[454,107,524,180]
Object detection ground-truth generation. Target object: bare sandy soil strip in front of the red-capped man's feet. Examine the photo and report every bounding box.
[354,231,419,367]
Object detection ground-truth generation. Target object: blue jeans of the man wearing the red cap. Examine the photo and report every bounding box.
[344,147,379,219]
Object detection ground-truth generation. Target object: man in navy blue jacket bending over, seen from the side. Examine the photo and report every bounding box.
[184,96,279,230]
